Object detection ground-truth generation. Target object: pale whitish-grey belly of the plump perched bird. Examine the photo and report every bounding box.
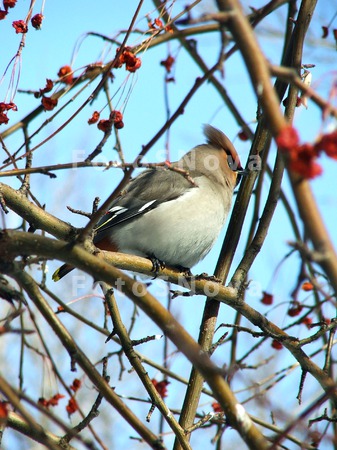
[114,189,227,268]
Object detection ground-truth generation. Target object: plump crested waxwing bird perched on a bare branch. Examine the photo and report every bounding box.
[53,125,244,281]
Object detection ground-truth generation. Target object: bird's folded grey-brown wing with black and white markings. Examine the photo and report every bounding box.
[94,168,195,243]
